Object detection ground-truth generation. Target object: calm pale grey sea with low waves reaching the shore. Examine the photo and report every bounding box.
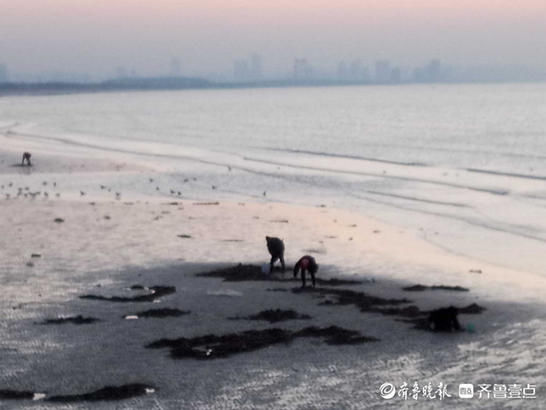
[0,84,546,274]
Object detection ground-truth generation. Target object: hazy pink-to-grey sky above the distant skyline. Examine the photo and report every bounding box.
[0,0,546,76]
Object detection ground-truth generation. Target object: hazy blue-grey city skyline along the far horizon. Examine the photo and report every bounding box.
[0,53,546,84]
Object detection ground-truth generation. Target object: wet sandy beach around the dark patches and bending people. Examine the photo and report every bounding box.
[0,147,546,408]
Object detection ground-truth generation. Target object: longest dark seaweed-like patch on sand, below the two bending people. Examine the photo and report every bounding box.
[146,326,378,360]
